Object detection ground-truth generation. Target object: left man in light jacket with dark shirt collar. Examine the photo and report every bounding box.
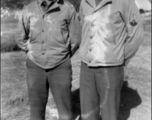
[16,0,80,120]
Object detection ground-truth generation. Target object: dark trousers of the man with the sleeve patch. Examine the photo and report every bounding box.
[80,62,124,120]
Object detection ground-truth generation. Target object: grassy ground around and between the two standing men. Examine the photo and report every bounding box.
[1,15,151,120]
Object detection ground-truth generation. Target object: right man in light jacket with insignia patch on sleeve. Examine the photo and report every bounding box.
[80,0,143,120]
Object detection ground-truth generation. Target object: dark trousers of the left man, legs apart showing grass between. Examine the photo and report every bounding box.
[26,59,72,120]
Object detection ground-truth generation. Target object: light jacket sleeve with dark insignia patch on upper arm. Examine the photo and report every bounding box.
[124,0,143,65]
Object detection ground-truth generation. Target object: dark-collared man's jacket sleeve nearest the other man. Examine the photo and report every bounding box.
[69,7,81,57]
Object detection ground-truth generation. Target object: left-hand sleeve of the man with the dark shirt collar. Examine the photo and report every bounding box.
[16,8,29,51]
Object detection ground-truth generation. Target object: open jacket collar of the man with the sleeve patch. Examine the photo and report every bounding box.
[85,0,112,11]
